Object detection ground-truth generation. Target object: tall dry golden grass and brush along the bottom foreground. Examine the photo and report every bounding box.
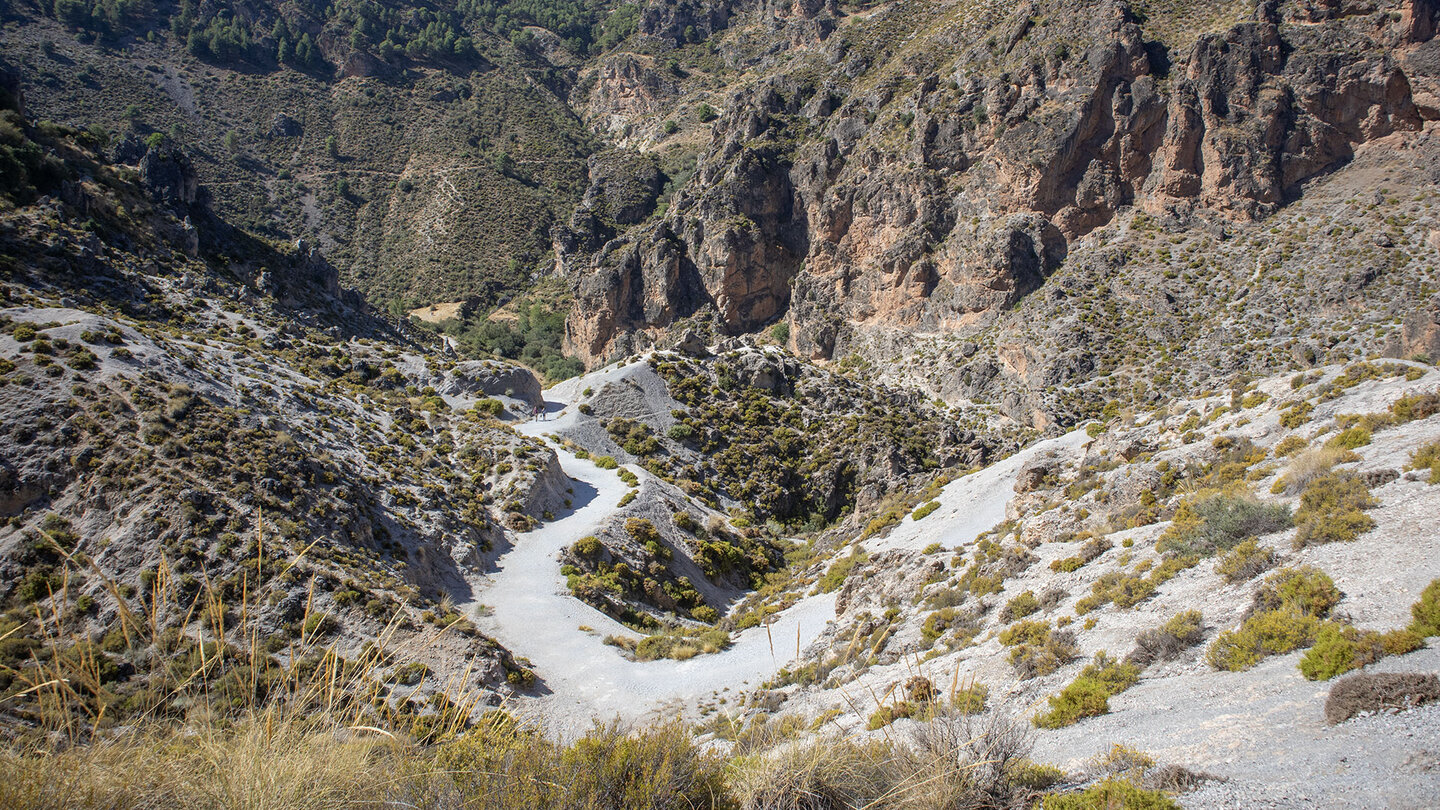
[0,515,1077,810]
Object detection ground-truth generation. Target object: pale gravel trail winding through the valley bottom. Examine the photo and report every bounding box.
[461,380,835,732]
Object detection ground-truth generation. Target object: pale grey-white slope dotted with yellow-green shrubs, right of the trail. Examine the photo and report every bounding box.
[771,363,1440,807]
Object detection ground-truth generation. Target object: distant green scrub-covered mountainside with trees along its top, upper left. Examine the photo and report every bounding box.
[3,3,592,307]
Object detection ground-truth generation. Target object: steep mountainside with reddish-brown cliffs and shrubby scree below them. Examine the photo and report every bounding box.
[559,0,1437,427]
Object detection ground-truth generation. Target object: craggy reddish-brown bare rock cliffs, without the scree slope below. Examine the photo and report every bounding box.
[562,0,1440,383]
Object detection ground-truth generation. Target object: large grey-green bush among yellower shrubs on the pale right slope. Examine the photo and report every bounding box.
[1155,489,1290,556]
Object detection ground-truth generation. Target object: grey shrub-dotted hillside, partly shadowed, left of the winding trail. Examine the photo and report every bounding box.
[0,99,572,724]
